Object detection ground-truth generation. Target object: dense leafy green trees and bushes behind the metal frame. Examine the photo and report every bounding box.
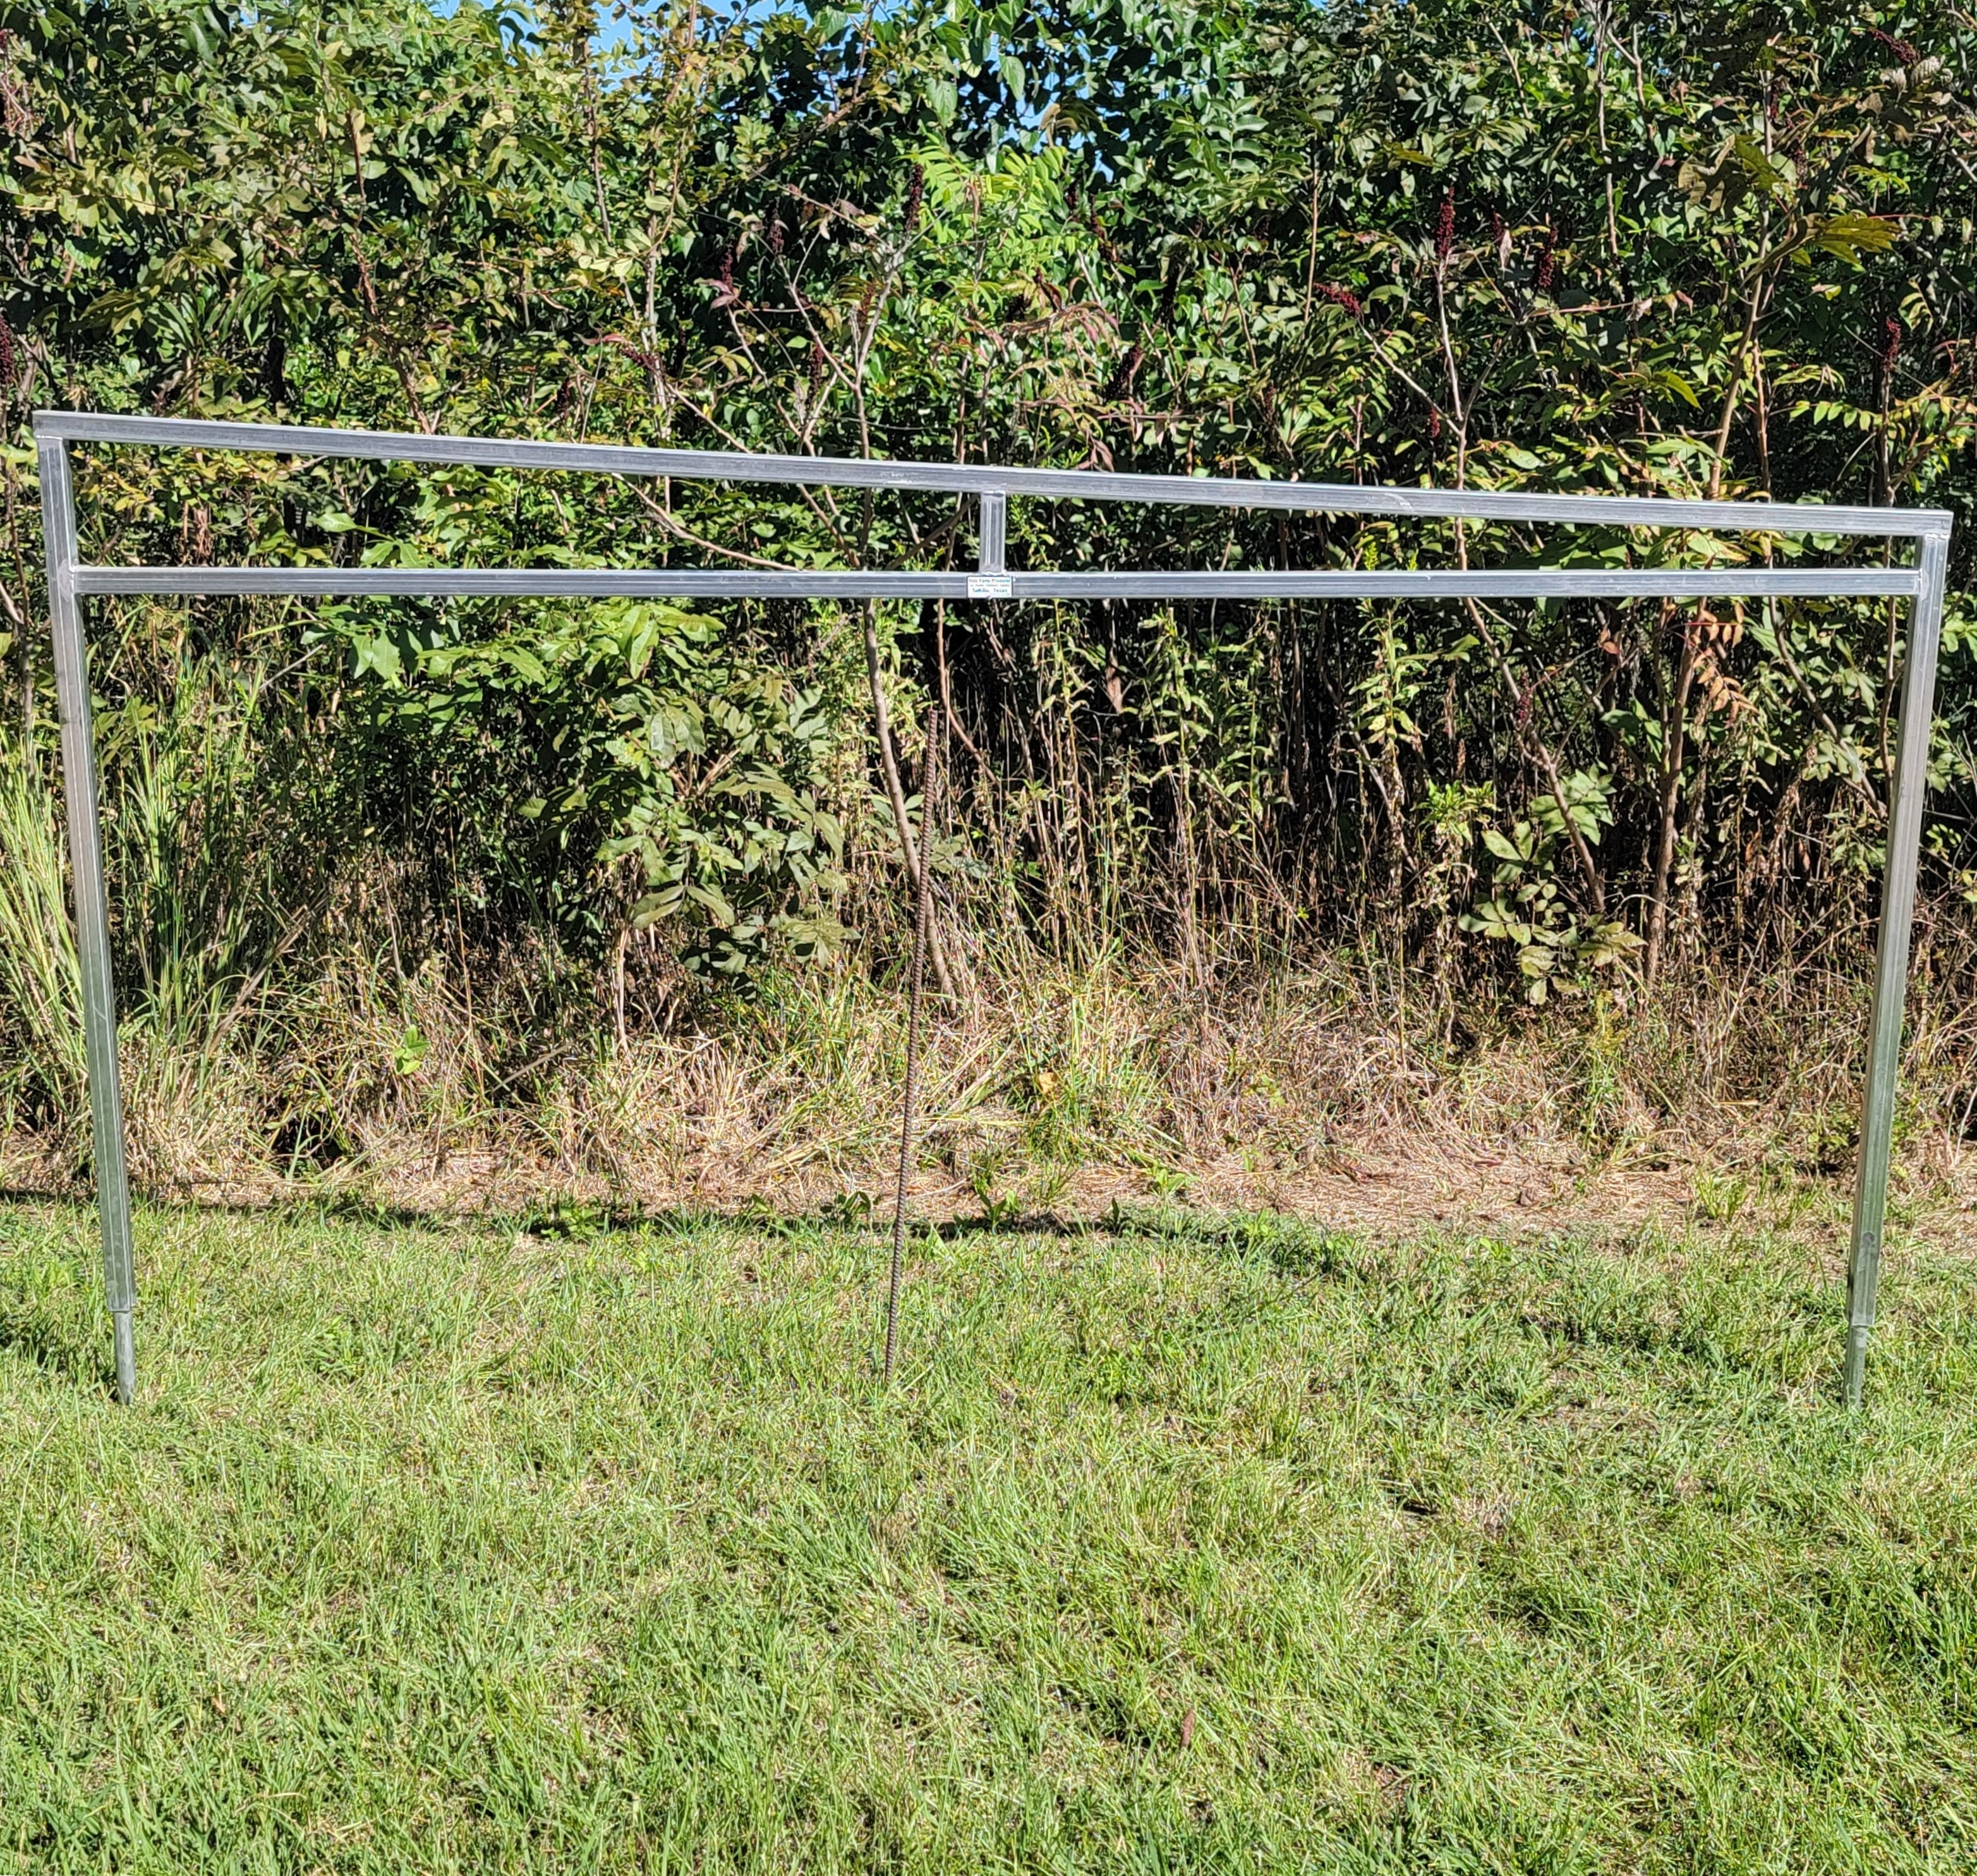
[0,0,1977,1139]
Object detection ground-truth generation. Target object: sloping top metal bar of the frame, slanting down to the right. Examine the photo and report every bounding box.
[33,411,1949,538]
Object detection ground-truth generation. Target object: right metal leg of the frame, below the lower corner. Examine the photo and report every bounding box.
[1846,528,1949,1408]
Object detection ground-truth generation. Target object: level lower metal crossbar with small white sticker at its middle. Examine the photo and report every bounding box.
[75,567,1918,599]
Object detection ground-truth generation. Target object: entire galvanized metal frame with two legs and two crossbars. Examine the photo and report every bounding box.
[33,411,1949,1405]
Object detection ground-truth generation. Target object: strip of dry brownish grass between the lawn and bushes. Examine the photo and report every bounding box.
[11,921,1977,1235]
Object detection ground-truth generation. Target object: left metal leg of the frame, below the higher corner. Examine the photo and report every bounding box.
[37,439,136,1405]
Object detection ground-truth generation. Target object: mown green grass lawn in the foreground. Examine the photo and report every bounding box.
[0,1206,1977,1872]
